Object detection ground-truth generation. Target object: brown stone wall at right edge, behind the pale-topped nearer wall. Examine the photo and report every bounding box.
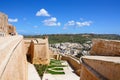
[90,39,120,56]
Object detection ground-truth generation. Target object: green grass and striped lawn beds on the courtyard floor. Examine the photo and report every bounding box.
[34,59,66,79]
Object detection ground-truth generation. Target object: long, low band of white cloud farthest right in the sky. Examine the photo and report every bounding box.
[65,20,92,27]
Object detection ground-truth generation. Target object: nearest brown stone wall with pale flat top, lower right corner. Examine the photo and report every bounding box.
[80,56,120,80]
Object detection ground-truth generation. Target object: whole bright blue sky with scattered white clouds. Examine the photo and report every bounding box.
[0,0,120,35]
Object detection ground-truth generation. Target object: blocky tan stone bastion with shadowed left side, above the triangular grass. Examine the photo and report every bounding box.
[28,38,50,64]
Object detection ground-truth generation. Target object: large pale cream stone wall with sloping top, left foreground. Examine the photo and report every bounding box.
[0,36,27,80]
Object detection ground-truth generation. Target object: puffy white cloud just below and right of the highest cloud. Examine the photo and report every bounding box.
[43,17,61,26]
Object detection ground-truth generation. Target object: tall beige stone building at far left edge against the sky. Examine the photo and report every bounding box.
[0,12,8,36]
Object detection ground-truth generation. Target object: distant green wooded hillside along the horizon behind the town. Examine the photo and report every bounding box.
[24,34,120,44]
